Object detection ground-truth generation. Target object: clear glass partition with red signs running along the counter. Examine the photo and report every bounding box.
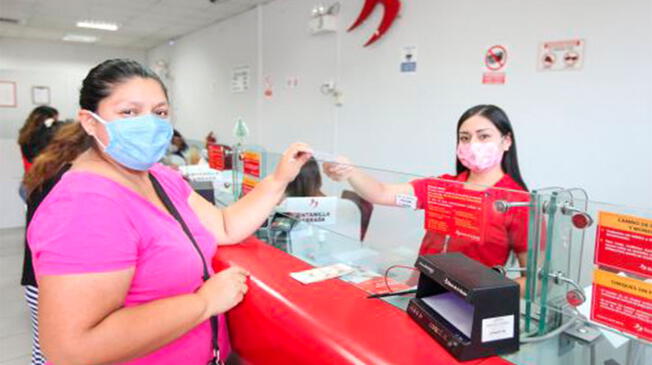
[176,146,652,364]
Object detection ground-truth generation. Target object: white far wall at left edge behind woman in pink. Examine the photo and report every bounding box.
[0,38,145,228]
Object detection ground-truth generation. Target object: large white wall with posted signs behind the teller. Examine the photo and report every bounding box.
[148,0,652,207]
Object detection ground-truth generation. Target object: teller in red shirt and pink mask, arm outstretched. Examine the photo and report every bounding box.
[324,105,528,292]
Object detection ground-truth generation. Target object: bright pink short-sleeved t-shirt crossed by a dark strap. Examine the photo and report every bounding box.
[27,164,230,365]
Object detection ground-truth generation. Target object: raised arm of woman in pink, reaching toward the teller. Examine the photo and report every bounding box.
[188,143,311,245]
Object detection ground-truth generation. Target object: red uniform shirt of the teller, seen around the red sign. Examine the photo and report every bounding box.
[410,171,530,267]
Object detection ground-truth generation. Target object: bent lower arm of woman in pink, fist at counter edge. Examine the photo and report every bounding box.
[39,268,247,365]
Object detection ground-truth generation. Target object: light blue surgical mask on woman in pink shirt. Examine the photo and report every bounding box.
[90,112,173,171]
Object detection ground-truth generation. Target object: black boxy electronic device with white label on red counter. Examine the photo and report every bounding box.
[407,253,520,361]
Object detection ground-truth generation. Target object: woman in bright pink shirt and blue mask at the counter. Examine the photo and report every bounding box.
[25,59,310,365]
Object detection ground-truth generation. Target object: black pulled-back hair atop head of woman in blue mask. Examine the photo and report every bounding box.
[79,58,168,112]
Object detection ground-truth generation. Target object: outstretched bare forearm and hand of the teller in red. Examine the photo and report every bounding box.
[324,158,414,205]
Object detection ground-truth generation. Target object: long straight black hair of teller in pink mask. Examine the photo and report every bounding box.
[456,105,528,190]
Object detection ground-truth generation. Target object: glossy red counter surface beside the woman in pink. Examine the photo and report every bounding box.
[213,238,510,365]
